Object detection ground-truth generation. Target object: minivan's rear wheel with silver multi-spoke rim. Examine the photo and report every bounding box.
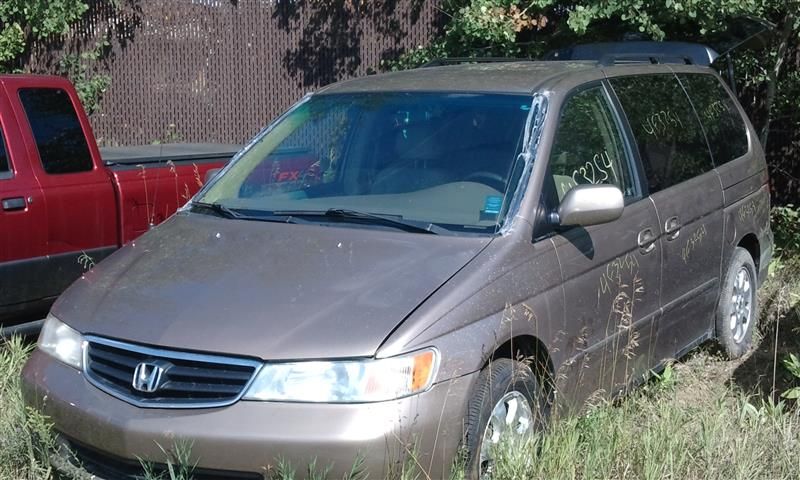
[715,247,758,359]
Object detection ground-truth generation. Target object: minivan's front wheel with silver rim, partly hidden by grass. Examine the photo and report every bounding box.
[464,358,545,479]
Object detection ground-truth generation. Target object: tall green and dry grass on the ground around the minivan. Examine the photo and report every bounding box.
[0,260,800,480]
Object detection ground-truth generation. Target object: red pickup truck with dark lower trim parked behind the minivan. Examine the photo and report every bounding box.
[0,75,238,327]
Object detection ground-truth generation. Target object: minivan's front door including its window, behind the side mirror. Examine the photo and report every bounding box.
[545,82,661,401]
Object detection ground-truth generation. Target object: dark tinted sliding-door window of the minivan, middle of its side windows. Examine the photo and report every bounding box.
[611,74,714,193]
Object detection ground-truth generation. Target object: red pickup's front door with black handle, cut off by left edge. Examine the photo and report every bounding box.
[0,89,47,323]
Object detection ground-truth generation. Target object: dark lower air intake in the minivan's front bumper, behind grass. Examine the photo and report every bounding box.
[55,436,264,480]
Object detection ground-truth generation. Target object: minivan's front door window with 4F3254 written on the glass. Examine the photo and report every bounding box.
[550,86,636,203]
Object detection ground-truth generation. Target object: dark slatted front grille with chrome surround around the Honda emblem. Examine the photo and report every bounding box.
[84,337,260,408]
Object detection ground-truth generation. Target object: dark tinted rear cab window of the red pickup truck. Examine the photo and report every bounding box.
[19,88,92,174]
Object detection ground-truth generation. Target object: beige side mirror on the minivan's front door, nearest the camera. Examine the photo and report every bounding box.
[557,185,625,227]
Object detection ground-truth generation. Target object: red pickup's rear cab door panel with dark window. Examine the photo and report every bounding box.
[6,77,117,304]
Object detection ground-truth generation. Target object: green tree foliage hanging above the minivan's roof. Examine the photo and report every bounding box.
[385,0,800,69]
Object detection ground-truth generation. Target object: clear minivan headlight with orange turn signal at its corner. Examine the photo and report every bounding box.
[244,349,438,403]
